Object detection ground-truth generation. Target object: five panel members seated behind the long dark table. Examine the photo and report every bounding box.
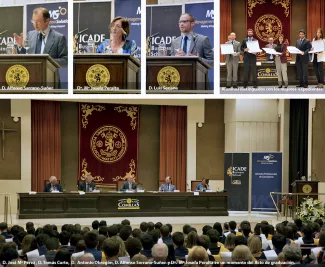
[43,177,210,193]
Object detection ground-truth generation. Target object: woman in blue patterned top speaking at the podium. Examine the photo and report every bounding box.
[96,17,139,57]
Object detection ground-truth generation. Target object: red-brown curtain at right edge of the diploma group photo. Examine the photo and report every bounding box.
[306,0,325,41]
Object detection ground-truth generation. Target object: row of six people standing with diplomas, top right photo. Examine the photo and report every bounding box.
[225,28,325,88]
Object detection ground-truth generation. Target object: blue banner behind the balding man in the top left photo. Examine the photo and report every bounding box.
[26,2,69,89]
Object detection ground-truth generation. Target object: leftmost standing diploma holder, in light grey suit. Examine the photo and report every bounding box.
[226,32,240,88]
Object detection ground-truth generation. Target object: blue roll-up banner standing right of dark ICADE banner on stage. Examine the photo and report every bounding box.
[252,152,282,211]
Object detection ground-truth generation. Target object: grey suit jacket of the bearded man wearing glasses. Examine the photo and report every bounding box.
[170,33,214,68]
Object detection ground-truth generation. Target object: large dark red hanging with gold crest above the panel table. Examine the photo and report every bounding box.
[79,103,139,186]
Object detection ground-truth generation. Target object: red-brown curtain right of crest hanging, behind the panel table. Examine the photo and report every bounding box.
[160,106,187,192]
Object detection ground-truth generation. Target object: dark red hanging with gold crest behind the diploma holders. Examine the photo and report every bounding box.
[246,0,292,60]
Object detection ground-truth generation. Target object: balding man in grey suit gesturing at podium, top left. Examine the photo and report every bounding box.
[14,7,68,67]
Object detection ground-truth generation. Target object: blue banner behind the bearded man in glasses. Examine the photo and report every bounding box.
[185,2,214,90]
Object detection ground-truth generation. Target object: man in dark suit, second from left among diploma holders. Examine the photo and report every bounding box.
[241,29,257,88]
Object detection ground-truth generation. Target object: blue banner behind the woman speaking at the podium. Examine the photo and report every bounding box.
[115,0,141,58]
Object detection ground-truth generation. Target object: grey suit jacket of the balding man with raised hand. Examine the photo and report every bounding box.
[19,29,68,67]
